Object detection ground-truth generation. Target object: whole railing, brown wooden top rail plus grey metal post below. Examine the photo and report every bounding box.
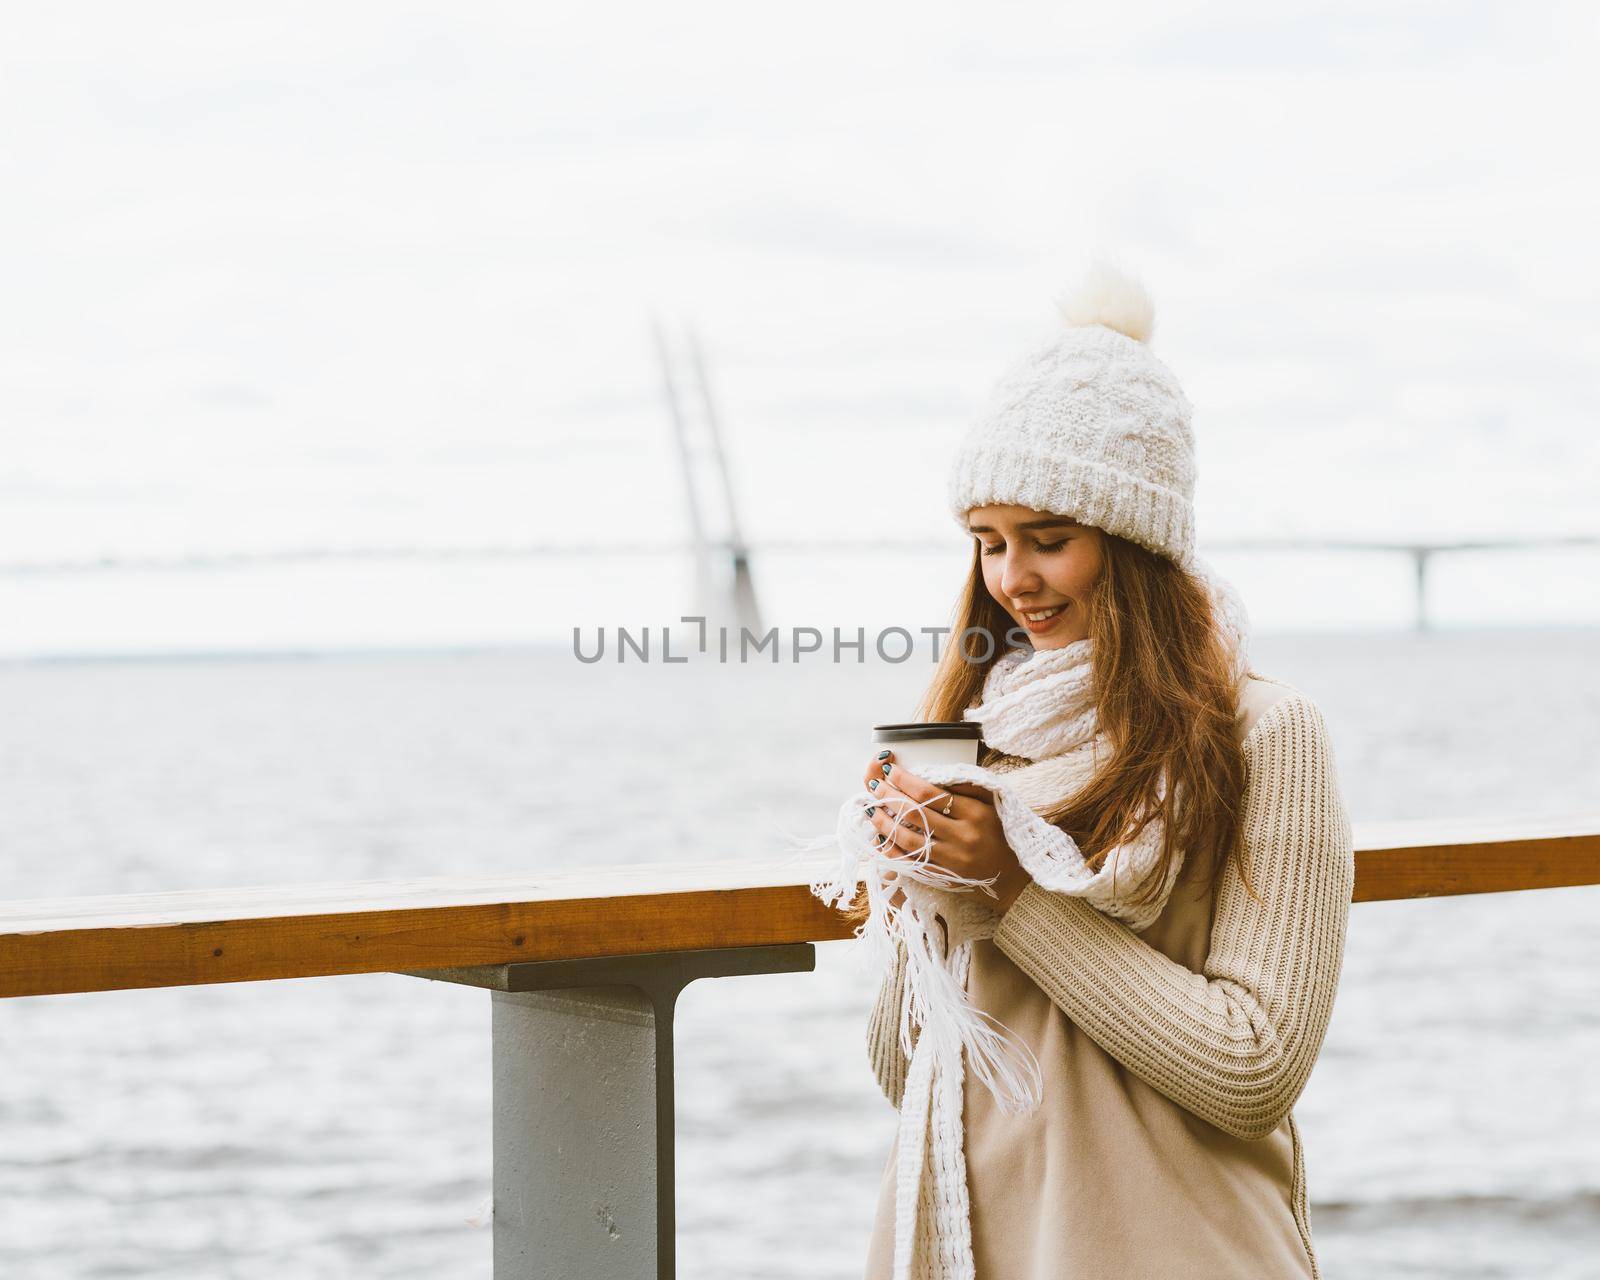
[0,814,1600,1280]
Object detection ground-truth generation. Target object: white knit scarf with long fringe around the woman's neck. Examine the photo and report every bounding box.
[811,557,1250,1280]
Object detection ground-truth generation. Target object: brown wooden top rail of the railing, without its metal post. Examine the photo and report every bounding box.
[0,813,1600,997]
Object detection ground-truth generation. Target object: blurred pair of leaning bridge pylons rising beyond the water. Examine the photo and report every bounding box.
[651,317,762,635]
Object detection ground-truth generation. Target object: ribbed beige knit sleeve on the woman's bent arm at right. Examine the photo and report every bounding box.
[994,693,1355,1139]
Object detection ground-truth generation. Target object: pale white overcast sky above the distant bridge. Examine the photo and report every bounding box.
[0,0,1600,651]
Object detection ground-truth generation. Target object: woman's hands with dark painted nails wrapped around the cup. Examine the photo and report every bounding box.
[862,752,1029,914]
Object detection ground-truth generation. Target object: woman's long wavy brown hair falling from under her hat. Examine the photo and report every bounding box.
[848,531,1259,923]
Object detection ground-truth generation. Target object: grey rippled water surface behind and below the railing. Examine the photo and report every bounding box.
[0,630,1600,1280]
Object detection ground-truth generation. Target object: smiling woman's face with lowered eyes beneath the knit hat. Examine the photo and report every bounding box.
[966,506,1106,650]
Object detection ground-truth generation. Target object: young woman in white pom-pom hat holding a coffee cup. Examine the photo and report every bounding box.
[856,269,1354,1280]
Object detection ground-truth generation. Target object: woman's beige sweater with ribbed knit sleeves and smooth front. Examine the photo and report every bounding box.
[866,675,1355,1280]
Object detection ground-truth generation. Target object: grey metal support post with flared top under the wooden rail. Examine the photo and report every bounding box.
[408,942,816,1280]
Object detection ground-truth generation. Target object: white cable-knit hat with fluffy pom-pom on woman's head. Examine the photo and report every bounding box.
[949,262,1195,568]
